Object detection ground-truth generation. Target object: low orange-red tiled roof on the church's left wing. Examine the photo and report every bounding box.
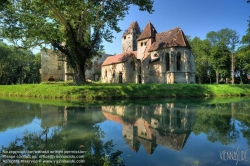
[102,51,137,66]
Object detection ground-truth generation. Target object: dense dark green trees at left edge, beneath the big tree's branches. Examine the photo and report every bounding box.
[0,42,41,84]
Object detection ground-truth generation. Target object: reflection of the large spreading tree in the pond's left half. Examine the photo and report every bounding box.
[0,108,124,165]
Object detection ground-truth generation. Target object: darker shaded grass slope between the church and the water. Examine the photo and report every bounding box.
[67,84,214,100]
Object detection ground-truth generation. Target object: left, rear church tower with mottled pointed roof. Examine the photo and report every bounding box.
[122,21,141,52]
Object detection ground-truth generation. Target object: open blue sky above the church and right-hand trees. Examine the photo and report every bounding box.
[103,0,250,54]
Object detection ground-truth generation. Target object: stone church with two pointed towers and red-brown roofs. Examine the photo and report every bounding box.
[101,22,195,84]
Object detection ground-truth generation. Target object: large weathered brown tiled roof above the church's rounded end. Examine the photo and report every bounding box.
[149,27,191,51]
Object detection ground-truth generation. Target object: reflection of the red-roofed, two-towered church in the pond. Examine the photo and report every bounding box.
[102,103,195,154]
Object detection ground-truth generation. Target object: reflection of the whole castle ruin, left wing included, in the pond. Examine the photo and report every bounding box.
[38,103,195,154]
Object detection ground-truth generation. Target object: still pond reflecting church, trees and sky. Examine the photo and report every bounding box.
[0,98,250,166]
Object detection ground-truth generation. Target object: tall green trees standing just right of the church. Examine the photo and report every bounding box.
[190,28,239,84]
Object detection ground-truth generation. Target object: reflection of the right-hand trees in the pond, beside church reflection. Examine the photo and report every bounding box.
[193,103,250,145]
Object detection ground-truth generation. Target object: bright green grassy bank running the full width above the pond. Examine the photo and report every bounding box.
[0,83,250,100]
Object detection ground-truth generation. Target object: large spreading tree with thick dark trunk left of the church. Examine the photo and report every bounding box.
[0,0,153,84]
